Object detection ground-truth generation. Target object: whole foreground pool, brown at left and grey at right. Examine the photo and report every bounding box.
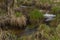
[3,28,37,36]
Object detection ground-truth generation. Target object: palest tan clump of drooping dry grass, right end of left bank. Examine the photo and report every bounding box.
[10,15,27,27]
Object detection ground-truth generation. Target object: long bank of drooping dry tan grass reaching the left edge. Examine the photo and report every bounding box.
[0,15,27,28]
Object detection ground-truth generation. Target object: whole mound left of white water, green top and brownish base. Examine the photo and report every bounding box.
[29,9,44,24]
